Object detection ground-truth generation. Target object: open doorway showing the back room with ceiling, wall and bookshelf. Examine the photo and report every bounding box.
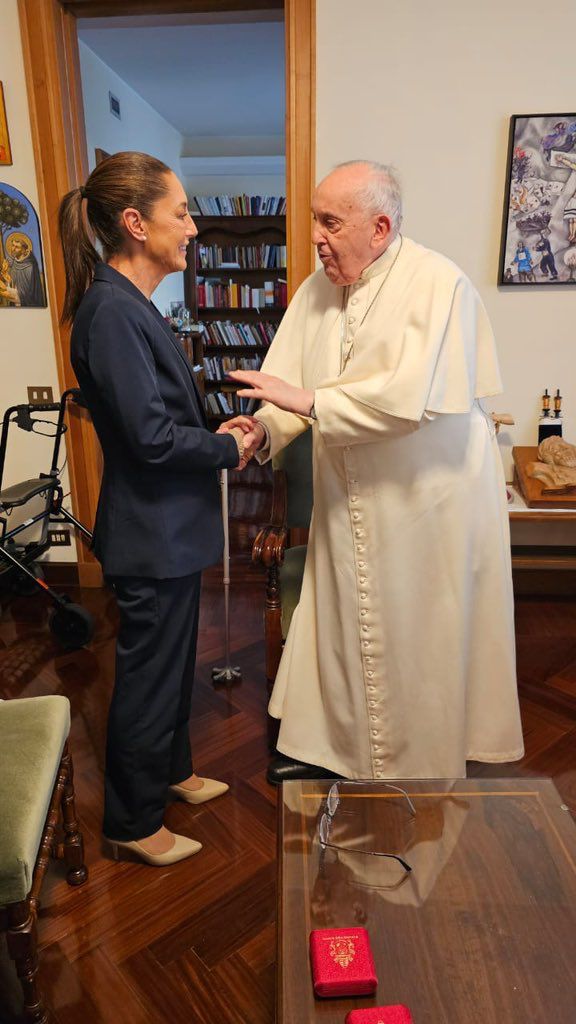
[78,9,287,574]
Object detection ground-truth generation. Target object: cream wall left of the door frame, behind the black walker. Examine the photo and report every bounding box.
[0,0,76,561]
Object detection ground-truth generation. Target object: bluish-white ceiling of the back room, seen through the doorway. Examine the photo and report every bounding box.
[78,15,285,138]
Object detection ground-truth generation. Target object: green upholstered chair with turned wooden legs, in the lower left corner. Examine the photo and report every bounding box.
[0,696,88,1024]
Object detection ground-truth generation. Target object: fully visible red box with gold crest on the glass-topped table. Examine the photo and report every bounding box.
[310,928,378,997]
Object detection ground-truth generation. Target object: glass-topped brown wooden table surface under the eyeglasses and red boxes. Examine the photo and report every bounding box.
[278,778,576,1024]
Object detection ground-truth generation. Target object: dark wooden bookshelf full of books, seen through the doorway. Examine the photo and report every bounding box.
[184,197,287,578]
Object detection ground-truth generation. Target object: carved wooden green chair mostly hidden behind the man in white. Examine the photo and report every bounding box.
[252,430,314,686]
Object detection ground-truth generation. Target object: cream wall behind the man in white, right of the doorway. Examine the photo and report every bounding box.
[317,0,576,476]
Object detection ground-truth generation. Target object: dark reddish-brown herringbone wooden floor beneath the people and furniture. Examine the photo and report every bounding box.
[0,584,576,1024]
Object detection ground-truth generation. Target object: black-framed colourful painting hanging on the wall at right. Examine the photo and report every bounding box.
[498,113,576,287]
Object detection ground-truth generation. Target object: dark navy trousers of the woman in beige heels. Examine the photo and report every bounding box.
[104,572,201,842]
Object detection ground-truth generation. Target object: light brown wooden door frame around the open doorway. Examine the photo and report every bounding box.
[18,0,316,587]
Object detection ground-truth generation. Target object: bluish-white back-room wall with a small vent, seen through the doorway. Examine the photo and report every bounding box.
[79,40,183,313]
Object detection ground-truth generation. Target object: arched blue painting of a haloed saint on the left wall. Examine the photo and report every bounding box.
[0,181,47,309]
